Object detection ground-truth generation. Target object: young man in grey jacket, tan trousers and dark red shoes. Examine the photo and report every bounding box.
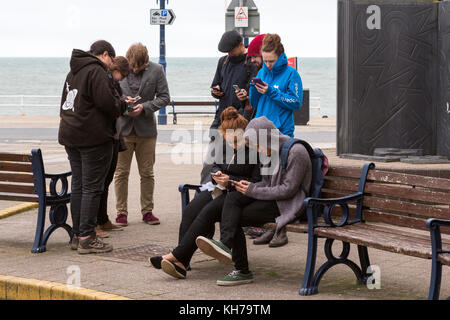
[114,43,170,226]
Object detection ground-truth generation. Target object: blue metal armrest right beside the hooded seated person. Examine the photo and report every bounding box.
[303,192,364,231]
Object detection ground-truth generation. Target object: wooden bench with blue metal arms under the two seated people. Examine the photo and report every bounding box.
[179,163,450,299]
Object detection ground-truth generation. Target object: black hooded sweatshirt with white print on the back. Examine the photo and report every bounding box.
[58,49,124,148]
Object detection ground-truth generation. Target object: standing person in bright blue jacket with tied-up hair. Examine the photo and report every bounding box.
[250,33,303,137]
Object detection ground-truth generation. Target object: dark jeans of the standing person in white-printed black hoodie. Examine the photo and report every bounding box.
[66,141,113,237]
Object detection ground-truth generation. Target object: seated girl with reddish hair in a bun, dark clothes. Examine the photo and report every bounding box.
[150,107,261,278]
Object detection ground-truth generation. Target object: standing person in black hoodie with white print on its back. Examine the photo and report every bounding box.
[58,40,126,254]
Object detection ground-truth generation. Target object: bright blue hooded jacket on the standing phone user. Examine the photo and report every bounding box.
[250,53,303,137]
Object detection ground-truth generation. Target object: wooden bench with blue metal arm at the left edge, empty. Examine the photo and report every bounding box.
[0,149,73,253]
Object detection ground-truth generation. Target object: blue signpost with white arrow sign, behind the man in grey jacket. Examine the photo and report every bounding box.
[150,0,176,125]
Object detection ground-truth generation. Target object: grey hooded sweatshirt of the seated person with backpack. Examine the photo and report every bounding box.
[244,117,312,232]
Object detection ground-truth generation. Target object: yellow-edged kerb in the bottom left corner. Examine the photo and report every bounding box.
[0,275,132,300]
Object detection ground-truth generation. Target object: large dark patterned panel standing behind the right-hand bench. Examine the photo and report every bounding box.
[338,1,438,154]
